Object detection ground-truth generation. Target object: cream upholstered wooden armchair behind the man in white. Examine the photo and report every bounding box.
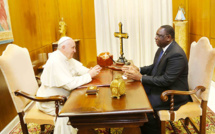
[0,44,66,134]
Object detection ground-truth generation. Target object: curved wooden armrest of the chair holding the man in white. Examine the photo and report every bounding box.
[14,90,67,105]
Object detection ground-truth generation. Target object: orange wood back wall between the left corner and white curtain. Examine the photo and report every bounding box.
[58,0,97,67]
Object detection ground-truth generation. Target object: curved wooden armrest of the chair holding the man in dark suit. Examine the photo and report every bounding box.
[160,86,205,102]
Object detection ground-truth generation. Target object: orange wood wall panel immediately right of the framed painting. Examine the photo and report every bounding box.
[9,0,41,51]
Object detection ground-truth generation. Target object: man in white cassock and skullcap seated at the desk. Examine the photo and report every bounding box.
[37,37,101,134]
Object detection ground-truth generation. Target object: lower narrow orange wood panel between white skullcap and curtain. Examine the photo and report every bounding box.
[84,39,97,67]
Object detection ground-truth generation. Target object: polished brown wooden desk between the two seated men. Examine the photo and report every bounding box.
[59,69,153,133]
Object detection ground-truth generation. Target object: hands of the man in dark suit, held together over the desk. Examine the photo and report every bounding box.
[124,66,142,81]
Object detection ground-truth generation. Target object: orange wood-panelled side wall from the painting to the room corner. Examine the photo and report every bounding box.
[6,0,59,61]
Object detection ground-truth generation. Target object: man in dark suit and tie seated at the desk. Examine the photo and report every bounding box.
[122,25,191,133]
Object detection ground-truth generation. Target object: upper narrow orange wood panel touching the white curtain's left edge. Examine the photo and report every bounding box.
[82,0,96,39]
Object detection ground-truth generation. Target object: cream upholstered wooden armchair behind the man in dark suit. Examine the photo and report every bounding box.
[158,37,215,134]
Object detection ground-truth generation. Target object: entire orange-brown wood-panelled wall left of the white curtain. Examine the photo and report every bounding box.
[0,0,96,131]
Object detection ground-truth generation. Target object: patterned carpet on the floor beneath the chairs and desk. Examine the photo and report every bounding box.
[10,108,215,134]
